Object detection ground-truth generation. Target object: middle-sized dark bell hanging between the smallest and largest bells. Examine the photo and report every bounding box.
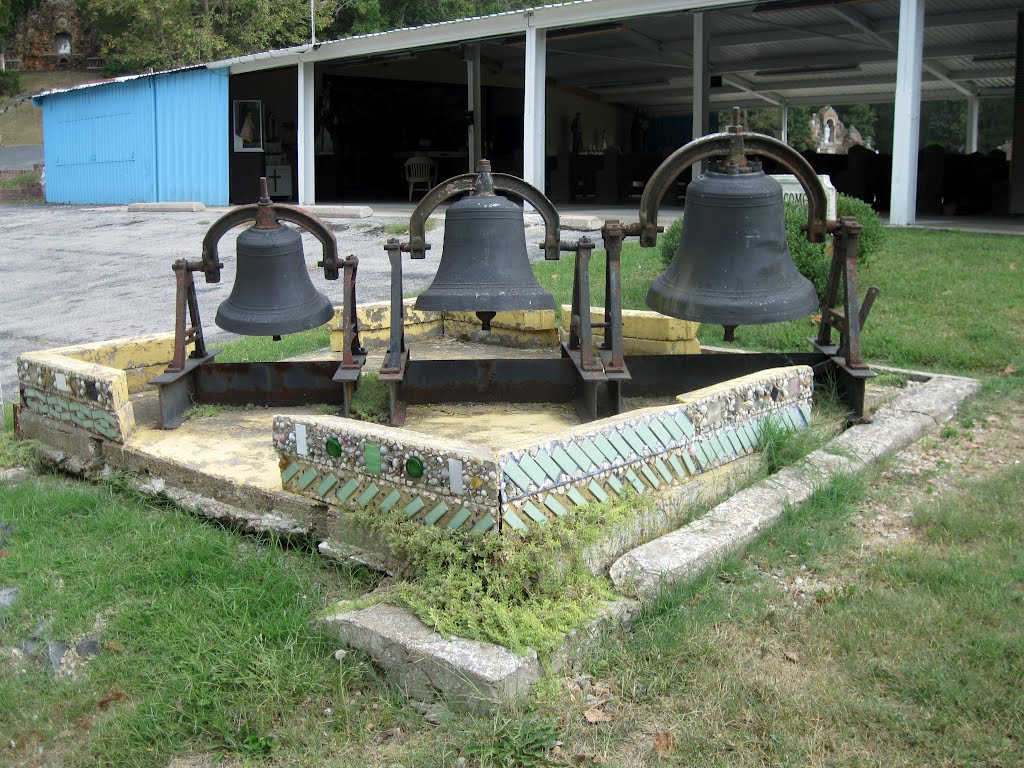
[416,161,555,330]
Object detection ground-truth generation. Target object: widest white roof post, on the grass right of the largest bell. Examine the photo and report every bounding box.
[889,0,925,225]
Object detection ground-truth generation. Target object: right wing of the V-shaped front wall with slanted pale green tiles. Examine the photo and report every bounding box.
[498,367,813,530]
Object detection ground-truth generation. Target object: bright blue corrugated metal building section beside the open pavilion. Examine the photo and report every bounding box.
[34,67,229,205]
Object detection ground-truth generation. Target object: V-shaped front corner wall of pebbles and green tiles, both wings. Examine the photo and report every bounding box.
[273,366,813,532]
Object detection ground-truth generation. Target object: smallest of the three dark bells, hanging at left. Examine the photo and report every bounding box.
[216,218,334,337]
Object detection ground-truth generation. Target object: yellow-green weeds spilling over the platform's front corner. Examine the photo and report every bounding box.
[354,498,643,655]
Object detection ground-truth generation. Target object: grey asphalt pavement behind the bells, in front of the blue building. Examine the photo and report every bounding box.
[0,204,594,402]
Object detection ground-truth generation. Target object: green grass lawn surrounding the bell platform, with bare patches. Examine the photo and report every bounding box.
[0,225,1024,768]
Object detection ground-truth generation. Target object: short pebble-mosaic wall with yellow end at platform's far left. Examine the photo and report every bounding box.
[17,350,135,442]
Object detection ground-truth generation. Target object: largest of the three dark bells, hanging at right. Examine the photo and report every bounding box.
[647,163,818,327]
